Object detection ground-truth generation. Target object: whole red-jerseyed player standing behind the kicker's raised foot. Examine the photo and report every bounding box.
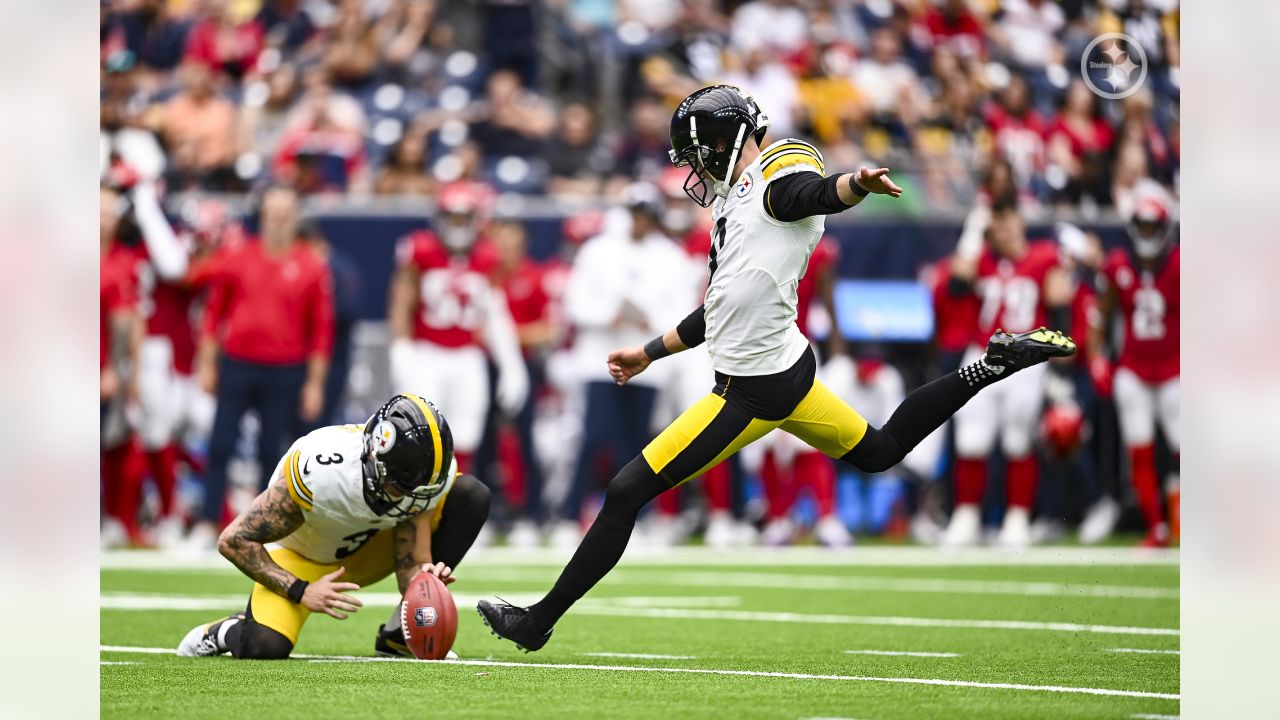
[943,201,1071,550]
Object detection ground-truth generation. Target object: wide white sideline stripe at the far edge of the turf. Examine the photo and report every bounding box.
[99,544,1180,573]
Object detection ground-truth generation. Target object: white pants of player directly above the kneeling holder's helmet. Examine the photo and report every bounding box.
[392,341,489,452]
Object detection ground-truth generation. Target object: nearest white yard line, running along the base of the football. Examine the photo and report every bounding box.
[99,646,1181,700]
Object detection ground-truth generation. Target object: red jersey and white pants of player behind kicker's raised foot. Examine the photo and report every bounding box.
[955,241,1059,459]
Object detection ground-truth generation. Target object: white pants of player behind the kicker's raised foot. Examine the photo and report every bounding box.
[955,347,1048,459]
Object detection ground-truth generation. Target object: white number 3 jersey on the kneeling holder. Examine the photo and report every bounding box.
[269,425,458,562]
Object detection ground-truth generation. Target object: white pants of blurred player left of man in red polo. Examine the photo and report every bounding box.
[134,336,215,450]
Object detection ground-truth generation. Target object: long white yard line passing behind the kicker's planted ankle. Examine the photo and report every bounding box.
[99,593,1180,635]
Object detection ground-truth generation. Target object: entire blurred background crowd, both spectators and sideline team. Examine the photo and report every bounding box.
[100,0,1179,548]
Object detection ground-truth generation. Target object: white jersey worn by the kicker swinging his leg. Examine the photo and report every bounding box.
[704,138,827,375]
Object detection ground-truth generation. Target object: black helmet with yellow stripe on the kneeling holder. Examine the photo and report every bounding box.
[360,393,453,518]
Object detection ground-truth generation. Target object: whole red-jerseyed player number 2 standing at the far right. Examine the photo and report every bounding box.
[1088,187,1181,547]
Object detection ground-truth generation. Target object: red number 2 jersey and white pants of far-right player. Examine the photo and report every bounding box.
[1102,247,1181,452]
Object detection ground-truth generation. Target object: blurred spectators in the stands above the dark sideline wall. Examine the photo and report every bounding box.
[101,0,1179,211]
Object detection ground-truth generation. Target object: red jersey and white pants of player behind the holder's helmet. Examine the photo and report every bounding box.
[392,231,527,454]
